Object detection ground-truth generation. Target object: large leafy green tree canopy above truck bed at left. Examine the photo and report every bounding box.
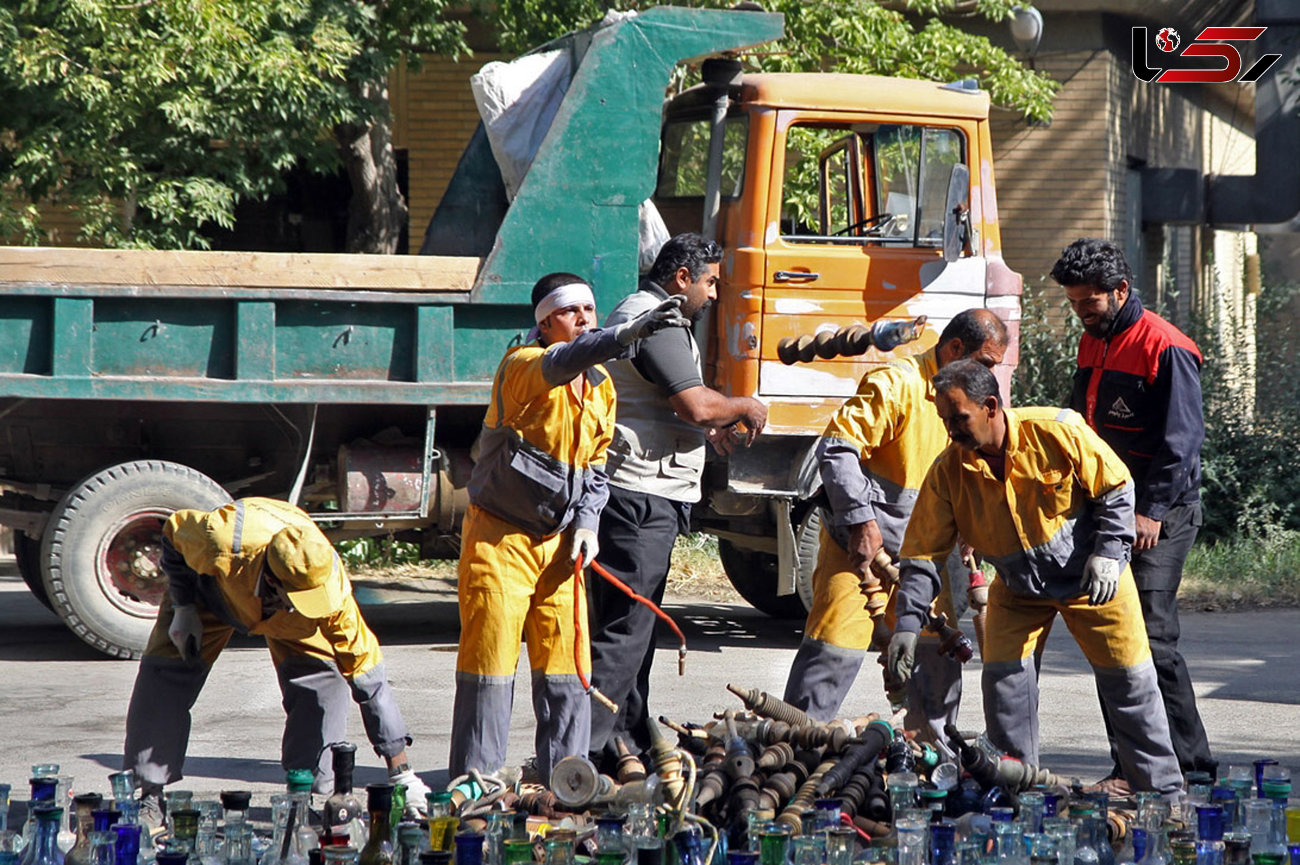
[0,0,464,247]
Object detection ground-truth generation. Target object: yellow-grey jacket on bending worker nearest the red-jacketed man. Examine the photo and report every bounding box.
[898,408,1134,630]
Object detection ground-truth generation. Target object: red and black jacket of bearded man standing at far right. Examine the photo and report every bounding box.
[1070,293,1205,520]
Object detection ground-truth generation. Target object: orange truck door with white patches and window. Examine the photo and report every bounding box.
[759,111,984,432]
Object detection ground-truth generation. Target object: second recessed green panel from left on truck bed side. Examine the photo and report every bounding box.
[93,298,234,379]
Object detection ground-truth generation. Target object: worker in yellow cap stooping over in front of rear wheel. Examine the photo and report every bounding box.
[124,498,429,805]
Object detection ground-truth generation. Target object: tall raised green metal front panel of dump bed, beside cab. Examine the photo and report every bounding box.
[476,7,783,310]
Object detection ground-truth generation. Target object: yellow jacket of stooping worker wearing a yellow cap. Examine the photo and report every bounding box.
[163,497,384,679]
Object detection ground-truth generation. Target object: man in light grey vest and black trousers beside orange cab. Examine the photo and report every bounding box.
[590,234,767,774]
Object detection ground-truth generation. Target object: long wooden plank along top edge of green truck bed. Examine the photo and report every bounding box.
[0,246,482,293]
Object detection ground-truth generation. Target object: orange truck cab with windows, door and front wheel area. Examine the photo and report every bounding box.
[654,64,1022,614]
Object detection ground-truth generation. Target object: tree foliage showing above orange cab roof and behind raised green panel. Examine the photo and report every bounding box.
[480,0,1060,120]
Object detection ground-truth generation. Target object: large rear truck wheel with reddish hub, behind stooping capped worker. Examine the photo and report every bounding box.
[42,459,230,658]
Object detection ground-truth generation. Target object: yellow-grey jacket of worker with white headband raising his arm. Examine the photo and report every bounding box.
[469,330,620,539]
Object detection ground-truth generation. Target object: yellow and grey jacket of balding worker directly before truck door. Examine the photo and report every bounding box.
[818,351,948,555]
